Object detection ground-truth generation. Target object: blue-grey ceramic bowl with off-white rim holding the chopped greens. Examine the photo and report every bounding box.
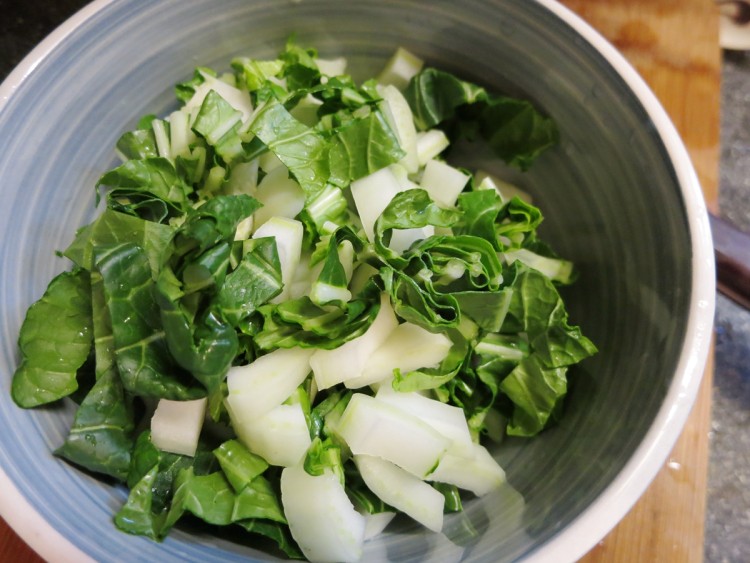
[0,0,714,562]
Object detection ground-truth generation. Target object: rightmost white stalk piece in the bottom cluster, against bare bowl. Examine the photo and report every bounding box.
[427,444,505,496]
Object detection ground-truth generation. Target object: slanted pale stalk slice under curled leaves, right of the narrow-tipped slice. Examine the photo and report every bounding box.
[344,323,452,389]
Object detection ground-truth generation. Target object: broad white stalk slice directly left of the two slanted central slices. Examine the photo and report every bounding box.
[226,348,312,422]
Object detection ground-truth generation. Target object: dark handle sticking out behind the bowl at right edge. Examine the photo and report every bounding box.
[709,214,750,309]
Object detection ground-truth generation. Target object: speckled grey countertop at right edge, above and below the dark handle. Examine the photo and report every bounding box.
[705,52,750,563]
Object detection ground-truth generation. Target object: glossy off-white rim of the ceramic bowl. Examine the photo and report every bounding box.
[0,0,716,563]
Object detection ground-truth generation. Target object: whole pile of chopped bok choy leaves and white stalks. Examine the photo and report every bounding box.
[12,42,596,561]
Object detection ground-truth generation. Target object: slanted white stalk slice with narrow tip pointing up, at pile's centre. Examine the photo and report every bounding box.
[310,294,398,389]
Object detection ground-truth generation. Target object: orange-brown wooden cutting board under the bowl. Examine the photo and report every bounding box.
[0,0,721,563]
